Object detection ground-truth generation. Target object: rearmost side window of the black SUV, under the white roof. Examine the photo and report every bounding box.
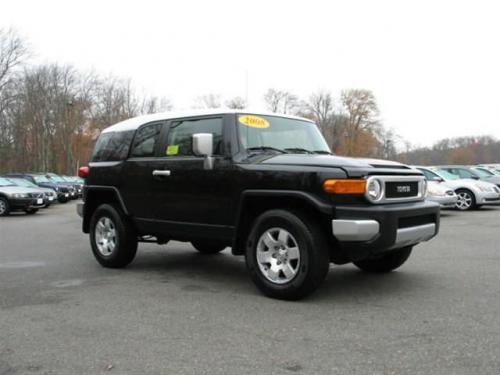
[90,131,134,162]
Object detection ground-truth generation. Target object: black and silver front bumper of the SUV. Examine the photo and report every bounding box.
[332,201,440,260]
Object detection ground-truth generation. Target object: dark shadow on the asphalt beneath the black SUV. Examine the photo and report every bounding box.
[123,249,433,304]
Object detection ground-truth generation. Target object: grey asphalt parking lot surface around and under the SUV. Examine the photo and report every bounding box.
[0,203,500,375]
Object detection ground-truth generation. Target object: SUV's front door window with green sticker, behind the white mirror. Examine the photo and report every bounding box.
[164,118,223,156]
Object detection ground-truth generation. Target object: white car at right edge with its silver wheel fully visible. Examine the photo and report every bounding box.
[414,166,500,211]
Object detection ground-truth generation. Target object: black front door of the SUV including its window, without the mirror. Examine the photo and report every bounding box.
[154,116,234,238]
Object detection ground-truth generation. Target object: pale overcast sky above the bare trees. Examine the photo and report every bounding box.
[0,0,500,145]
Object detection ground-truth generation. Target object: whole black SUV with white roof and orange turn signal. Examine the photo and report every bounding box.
[77,111,439,299]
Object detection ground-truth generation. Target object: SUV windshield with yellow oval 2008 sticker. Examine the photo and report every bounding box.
[238,115,330,154]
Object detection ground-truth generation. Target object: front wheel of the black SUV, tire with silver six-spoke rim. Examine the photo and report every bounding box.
[245,209,330,300]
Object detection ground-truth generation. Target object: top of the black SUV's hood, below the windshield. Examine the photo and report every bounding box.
[261,154,411,170]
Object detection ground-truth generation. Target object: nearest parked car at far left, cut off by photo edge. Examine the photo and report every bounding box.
[0,177,44,216]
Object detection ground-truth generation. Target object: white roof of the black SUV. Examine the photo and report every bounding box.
[102,109,313,133]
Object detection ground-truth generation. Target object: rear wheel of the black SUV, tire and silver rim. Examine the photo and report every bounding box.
[90,204,137,268]
